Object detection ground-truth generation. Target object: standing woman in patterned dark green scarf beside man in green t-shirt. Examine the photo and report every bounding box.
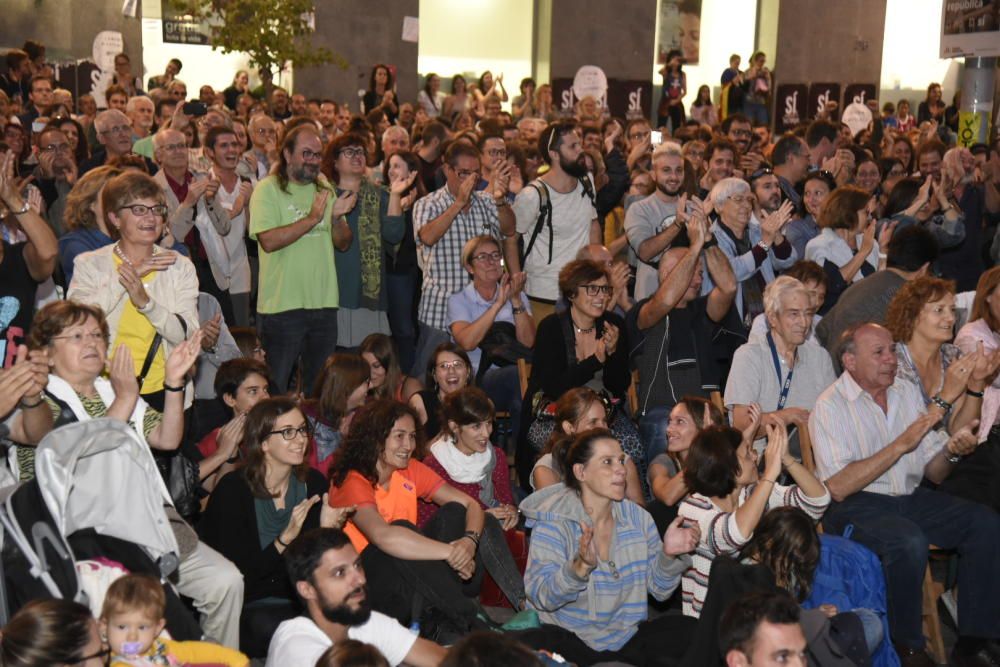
[322,133,417,348]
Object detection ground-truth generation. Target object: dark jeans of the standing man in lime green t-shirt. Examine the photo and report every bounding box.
[257,308,337,394]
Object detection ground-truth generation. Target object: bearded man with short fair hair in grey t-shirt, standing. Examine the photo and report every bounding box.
[625,141,687,300]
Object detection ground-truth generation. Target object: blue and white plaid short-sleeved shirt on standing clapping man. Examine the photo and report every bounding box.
[413,185,500,330]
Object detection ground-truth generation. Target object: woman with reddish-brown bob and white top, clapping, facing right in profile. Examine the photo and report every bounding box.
[806,186,896,306]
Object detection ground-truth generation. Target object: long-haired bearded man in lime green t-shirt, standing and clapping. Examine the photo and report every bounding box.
[250,125,357,391]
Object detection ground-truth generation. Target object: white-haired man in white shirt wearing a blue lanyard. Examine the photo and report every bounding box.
[725,276,837,455]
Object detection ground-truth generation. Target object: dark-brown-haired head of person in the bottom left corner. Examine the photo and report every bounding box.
[0,600,111,667]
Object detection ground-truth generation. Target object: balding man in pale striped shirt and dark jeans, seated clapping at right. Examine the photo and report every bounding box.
[809,324,1000,665]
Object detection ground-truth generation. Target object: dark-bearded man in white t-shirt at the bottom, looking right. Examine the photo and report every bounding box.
[267,528,445,667]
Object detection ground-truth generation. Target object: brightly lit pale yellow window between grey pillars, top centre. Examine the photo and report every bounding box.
[417,0,534,103]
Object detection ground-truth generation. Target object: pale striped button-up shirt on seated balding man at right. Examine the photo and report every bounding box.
[809,371,948,496]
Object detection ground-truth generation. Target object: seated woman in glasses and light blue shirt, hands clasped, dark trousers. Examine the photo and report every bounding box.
[448,235,535,440]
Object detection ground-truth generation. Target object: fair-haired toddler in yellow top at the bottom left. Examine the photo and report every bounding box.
[100,574,250,667]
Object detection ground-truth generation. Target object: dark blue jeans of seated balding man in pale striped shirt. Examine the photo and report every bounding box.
[823,488,1000,648]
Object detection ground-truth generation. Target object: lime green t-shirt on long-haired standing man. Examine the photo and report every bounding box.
[250,176,340,314]
